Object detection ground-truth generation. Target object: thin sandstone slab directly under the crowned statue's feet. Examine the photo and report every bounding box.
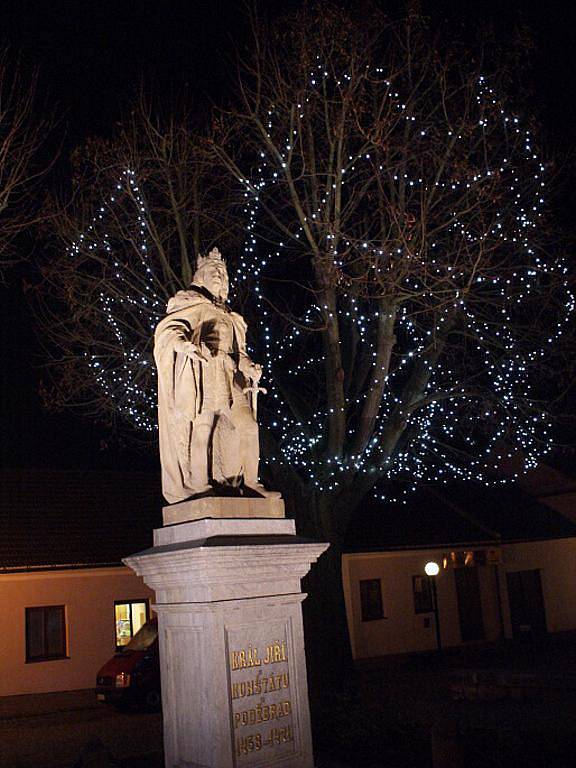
[162,496,284,525]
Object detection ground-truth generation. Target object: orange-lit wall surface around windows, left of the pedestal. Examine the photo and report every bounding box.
[0,567,154,696]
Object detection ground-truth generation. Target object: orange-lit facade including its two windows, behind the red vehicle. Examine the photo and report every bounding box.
[0,566,154,696]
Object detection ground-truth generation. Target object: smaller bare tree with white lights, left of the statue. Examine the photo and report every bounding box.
[34,95,238,433]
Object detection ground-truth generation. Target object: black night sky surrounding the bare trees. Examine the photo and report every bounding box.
[0,0,576,468]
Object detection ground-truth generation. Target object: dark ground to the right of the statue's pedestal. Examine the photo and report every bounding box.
[316,633,576,768]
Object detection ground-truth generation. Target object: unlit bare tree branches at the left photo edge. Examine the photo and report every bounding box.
[0,46,53,278]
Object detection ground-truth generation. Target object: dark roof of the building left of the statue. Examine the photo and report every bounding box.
[0,469,163,572]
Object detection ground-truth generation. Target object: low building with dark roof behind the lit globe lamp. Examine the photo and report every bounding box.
[342,486,576,660]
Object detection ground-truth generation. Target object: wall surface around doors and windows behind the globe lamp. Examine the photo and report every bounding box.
[342,539,576,659]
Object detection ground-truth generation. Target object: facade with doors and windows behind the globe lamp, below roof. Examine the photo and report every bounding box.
[343,538,576,660]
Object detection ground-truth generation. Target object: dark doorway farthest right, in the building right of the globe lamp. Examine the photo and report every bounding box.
[506,570,548,639]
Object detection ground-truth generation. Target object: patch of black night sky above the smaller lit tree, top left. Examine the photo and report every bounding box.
[0,0,241,140]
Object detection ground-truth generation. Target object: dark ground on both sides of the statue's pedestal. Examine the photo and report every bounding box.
[0,635,576,768]
